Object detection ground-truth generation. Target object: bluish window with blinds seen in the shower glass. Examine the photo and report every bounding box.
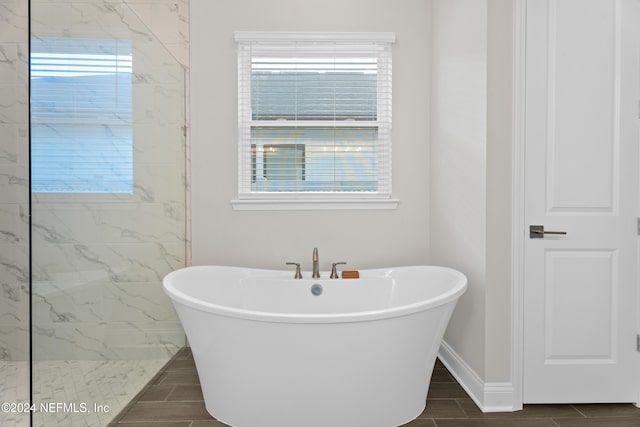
[31,37,133,194]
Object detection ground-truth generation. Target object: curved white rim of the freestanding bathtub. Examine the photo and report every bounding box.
[162,265,468,324]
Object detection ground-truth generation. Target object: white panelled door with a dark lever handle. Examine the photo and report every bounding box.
[523,0,640,403]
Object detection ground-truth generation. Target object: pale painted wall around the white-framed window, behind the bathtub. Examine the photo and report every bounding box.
[190,0,430,271]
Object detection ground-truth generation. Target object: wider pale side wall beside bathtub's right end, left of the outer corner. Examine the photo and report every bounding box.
[430,0,487,378]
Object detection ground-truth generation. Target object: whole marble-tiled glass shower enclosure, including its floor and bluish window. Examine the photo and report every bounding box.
[0,0,188,427]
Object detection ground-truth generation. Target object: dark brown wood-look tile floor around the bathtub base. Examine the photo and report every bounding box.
[109,348,640,427]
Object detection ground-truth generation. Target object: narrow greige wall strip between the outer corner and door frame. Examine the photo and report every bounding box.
[484,0,514,382]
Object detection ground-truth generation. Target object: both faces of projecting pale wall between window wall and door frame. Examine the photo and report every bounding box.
[430,0,513,384]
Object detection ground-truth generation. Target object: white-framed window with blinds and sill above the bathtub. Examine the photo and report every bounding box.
[234,32,397,209]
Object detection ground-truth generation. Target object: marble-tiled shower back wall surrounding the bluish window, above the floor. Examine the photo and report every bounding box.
[31,0,188,361]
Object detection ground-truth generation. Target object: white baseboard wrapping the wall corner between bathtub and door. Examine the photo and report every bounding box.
[438,341,516,412]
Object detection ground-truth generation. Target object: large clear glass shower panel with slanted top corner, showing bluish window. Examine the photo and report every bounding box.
[30,0,186,427]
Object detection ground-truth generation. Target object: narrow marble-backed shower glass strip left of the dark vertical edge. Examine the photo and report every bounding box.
[0,0,29,427]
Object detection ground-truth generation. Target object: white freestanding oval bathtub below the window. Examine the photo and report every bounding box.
[163,266,467,427]
